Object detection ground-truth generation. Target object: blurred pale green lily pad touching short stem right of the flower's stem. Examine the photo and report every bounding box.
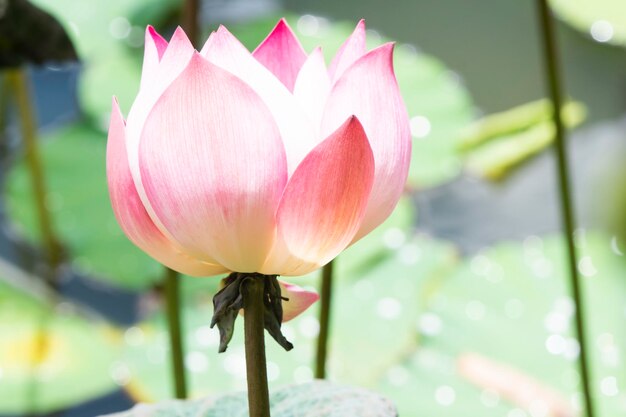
[329,236,458,384]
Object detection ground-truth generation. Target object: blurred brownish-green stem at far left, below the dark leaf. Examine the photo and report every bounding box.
[6,68,61,282]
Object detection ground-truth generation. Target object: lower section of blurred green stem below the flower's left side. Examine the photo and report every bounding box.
[165,268,187,399]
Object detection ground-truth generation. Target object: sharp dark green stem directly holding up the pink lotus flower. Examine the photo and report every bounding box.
[242,276,270,417]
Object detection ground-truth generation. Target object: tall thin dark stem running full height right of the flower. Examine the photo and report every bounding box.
[537,0,594,417]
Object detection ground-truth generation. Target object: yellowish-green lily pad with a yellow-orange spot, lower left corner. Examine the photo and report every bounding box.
[0,281,118,414]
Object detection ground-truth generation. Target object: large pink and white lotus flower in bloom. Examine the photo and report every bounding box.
[107,20,411,316]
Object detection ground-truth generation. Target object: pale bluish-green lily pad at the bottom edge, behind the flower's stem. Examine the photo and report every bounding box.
[103,381,397,417]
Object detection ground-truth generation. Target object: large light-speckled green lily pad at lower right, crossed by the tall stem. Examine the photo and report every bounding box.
[352,233,626,417]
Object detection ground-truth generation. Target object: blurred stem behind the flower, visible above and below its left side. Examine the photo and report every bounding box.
[160,0,199,399]
